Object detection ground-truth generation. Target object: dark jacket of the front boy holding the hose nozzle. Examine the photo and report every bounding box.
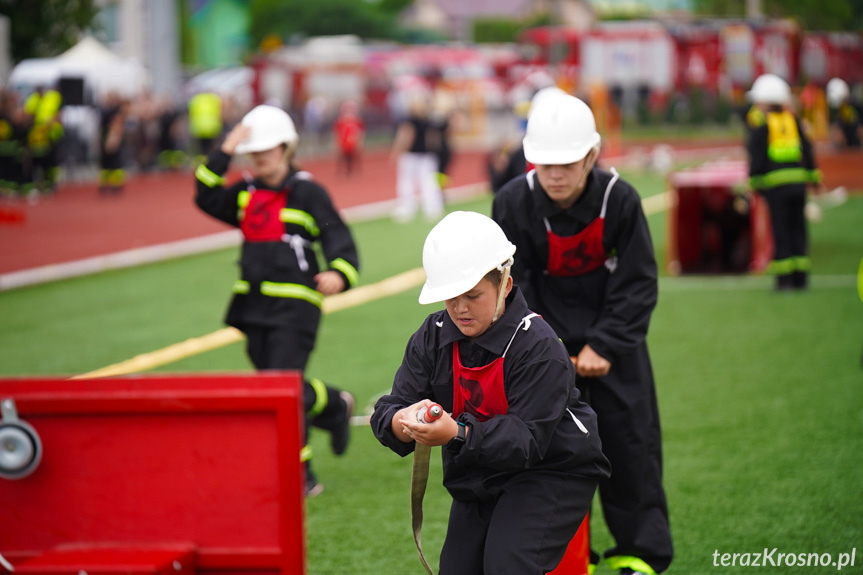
[371,288,609,501]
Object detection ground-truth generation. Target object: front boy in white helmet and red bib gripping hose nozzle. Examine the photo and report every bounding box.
[371,212,609,575]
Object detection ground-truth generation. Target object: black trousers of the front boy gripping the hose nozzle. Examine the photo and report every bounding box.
[440,470,597,575]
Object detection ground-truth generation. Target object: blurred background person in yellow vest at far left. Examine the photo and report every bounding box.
[24,88,63,192]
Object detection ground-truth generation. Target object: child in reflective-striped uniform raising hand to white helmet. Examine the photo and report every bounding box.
[195,106,359,497]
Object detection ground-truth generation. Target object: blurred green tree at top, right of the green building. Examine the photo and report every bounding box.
[249,0,396,45]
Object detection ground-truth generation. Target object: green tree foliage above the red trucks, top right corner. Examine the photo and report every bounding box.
[694,0,863,30]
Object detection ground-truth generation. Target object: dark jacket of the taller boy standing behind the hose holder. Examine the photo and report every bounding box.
[492,169,658,363]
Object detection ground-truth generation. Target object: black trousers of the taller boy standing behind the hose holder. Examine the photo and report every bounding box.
[570,344,673,573]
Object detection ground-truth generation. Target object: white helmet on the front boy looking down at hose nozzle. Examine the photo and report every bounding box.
[419,212,515,304]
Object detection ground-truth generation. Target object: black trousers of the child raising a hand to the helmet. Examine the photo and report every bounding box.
[243,326,347,441]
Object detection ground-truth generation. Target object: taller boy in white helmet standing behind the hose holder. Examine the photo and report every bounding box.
[492,94,673,575]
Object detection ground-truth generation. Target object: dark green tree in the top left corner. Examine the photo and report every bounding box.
[0,0,99,63]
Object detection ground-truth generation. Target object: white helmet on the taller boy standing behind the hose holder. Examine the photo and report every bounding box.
[524,94,601,166]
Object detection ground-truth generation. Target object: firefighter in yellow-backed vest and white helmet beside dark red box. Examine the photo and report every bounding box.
[746,74,821,291]
